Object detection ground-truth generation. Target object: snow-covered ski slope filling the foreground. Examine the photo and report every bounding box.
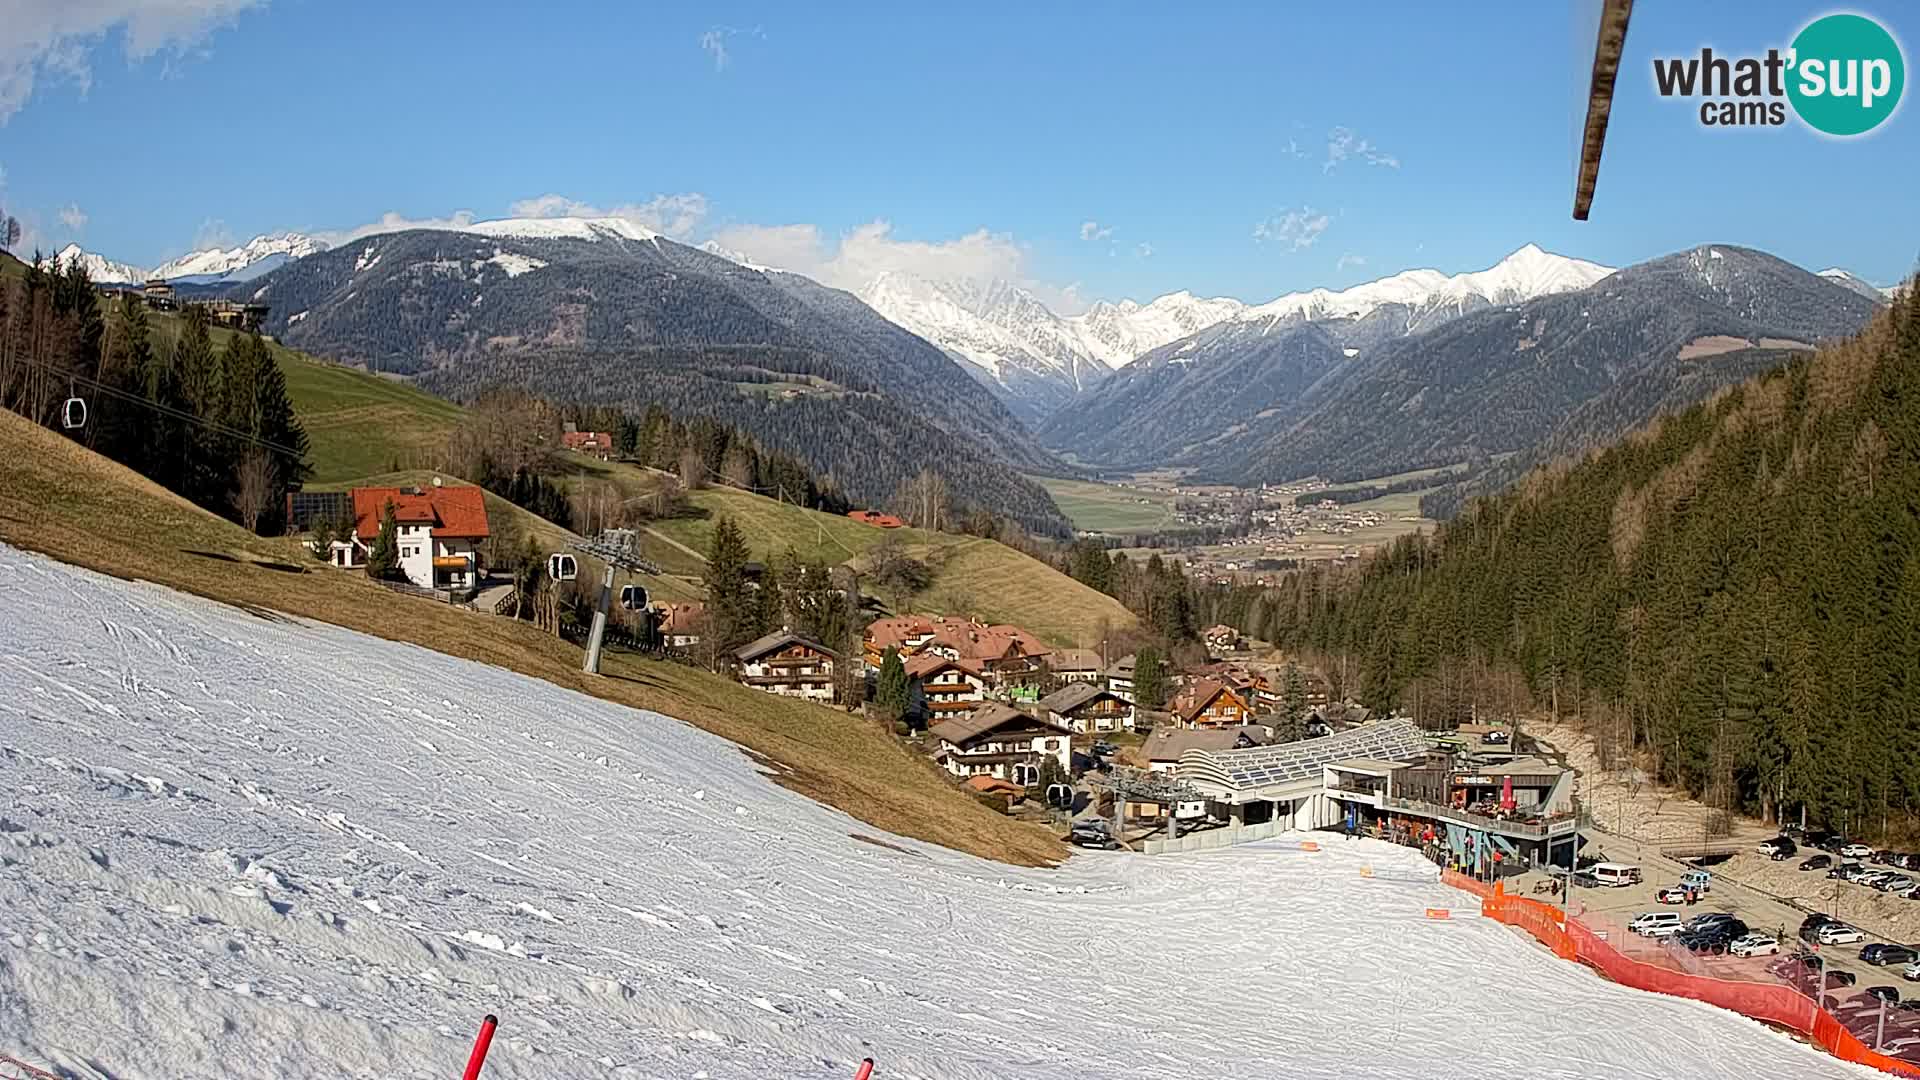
[0,548,1866,1080]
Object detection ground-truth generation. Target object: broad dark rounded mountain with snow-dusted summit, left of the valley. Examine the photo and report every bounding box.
[247,221,1068,534]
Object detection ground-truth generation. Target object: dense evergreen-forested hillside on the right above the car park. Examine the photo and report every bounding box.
[1265,294,1920,832]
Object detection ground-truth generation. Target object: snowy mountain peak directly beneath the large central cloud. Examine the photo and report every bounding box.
[856,271,1108,421]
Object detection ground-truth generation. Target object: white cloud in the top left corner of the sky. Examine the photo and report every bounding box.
[0,0,265,125]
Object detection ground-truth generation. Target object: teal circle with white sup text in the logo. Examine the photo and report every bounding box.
[1788,15,1907,136]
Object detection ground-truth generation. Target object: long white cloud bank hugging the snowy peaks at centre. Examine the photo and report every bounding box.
[708,221,1087,315]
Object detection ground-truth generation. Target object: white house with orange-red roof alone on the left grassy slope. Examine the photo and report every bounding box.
[328,482,490,592]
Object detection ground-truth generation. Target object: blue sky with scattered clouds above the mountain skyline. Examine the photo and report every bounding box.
[0,0,1920,306]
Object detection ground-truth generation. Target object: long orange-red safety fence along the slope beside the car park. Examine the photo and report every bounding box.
[1466,874,1920,1078]
